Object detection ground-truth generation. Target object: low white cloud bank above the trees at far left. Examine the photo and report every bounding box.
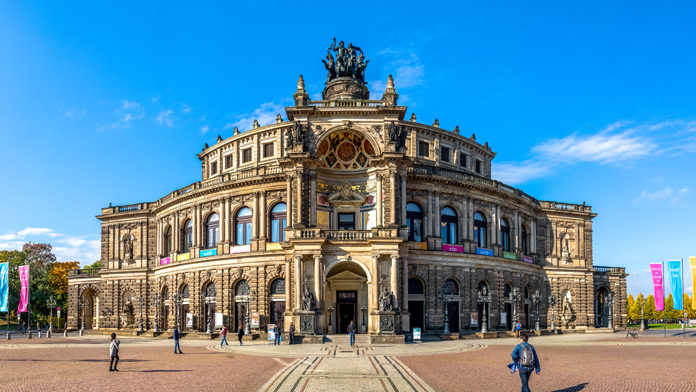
[0,227,101,265]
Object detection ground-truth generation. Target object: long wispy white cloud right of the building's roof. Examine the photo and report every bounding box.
[493,120,696,185]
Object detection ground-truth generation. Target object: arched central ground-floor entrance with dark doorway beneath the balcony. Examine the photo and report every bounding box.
[324,260,372,334]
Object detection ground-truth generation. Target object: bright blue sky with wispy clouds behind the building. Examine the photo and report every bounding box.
[0,1,696,293]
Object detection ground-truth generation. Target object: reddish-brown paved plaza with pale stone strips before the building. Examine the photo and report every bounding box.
[0,332,696,392]
